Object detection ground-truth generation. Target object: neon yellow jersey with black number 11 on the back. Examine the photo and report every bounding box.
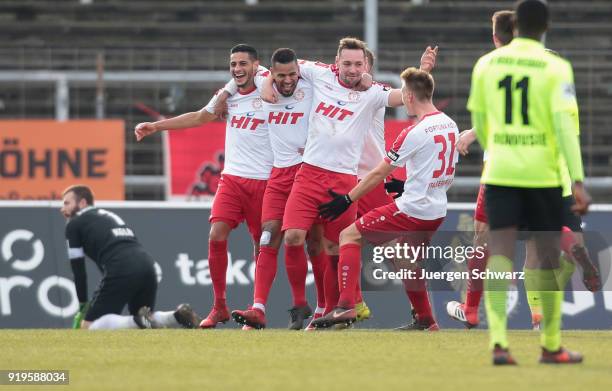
[468,38,584,188]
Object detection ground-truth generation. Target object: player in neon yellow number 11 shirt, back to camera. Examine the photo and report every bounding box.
[468,0,590,365]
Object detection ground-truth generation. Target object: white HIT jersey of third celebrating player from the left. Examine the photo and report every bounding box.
[300,61,391,175]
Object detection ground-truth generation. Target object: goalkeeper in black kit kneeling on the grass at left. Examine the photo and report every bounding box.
[61,185,199,330]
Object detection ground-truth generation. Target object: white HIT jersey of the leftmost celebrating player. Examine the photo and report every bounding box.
[205,89,273,179]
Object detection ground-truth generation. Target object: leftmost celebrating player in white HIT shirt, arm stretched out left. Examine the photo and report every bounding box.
[135,44,273,328]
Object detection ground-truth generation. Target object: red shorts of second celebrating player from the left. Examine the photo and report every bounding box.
[261,163,302,223]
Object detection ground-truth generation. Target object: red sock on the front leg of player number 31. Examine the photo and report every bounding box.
[338,243,361,308]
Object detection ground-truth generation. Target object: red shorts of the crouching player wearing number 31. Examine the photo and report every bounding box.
[355,202,444,244]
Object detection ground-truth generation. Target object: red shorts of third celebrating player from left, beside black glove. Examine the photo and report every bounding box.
[283,163,357,243]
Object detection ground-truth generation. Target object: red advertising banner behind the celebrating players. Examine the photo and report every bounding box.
[167,120,411,201]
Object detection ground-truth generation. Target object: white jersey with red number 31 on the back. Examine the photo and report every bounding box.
[385,111,459,220]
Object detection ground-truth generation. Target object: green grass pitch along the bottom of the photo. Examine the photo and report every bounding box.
[0,330,612,391]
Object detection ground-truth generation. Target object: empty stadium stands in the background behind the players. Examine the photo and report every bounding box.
[0,0,612,201]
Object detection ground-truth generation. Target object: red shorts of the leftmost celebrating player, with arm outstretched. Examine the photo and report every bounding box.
[209,174,267,242]
